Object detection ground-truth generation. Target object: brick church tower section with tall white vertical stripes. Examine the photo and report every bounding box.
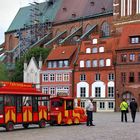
[113,0,140,31]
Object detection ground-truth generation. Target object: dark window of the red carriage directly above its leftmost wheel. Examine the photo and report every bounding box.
[4,95,15,106]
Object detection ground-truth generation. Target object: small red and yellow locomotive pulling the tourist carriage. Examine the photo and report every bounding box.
[49,96,87,125]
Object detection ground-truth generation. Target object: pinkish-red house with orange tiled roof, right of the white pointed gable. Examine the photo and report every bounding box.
[40,46,77,96]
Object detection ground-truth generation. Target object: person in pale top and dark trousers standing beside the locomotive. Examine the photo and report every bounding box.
[86,98,95,126]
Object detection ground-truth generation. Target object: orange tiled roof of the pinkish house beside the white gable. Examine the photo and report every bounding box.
[47,46,76,61]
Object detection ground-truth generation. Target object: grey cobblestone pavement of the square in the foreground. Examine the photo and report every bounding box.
[0,113,140,140]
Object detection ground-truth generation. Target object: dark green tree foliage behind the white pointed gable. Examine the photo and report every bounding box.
[12,47,50,82]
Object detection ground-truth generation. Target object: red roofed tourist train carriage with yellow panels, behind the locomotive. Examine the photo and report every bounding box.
[0,82,50,131]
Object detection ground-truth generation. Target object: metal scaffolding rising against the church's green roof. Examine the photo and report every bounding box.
[12,1,52,61]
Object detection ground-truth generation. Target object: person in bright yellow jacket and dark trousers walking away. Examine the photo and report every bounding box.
[120,99,128,122]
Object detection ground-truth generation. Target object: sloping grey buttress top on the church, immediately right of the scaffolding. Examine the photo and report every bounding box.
[29,33,52,48]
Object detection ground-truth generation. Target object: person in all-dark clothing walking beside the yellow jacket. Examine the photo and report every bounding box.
[130,98,138,122]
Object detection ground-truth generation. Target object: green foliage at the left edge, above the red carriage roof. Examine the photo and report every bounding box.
[0,63,9,81]
